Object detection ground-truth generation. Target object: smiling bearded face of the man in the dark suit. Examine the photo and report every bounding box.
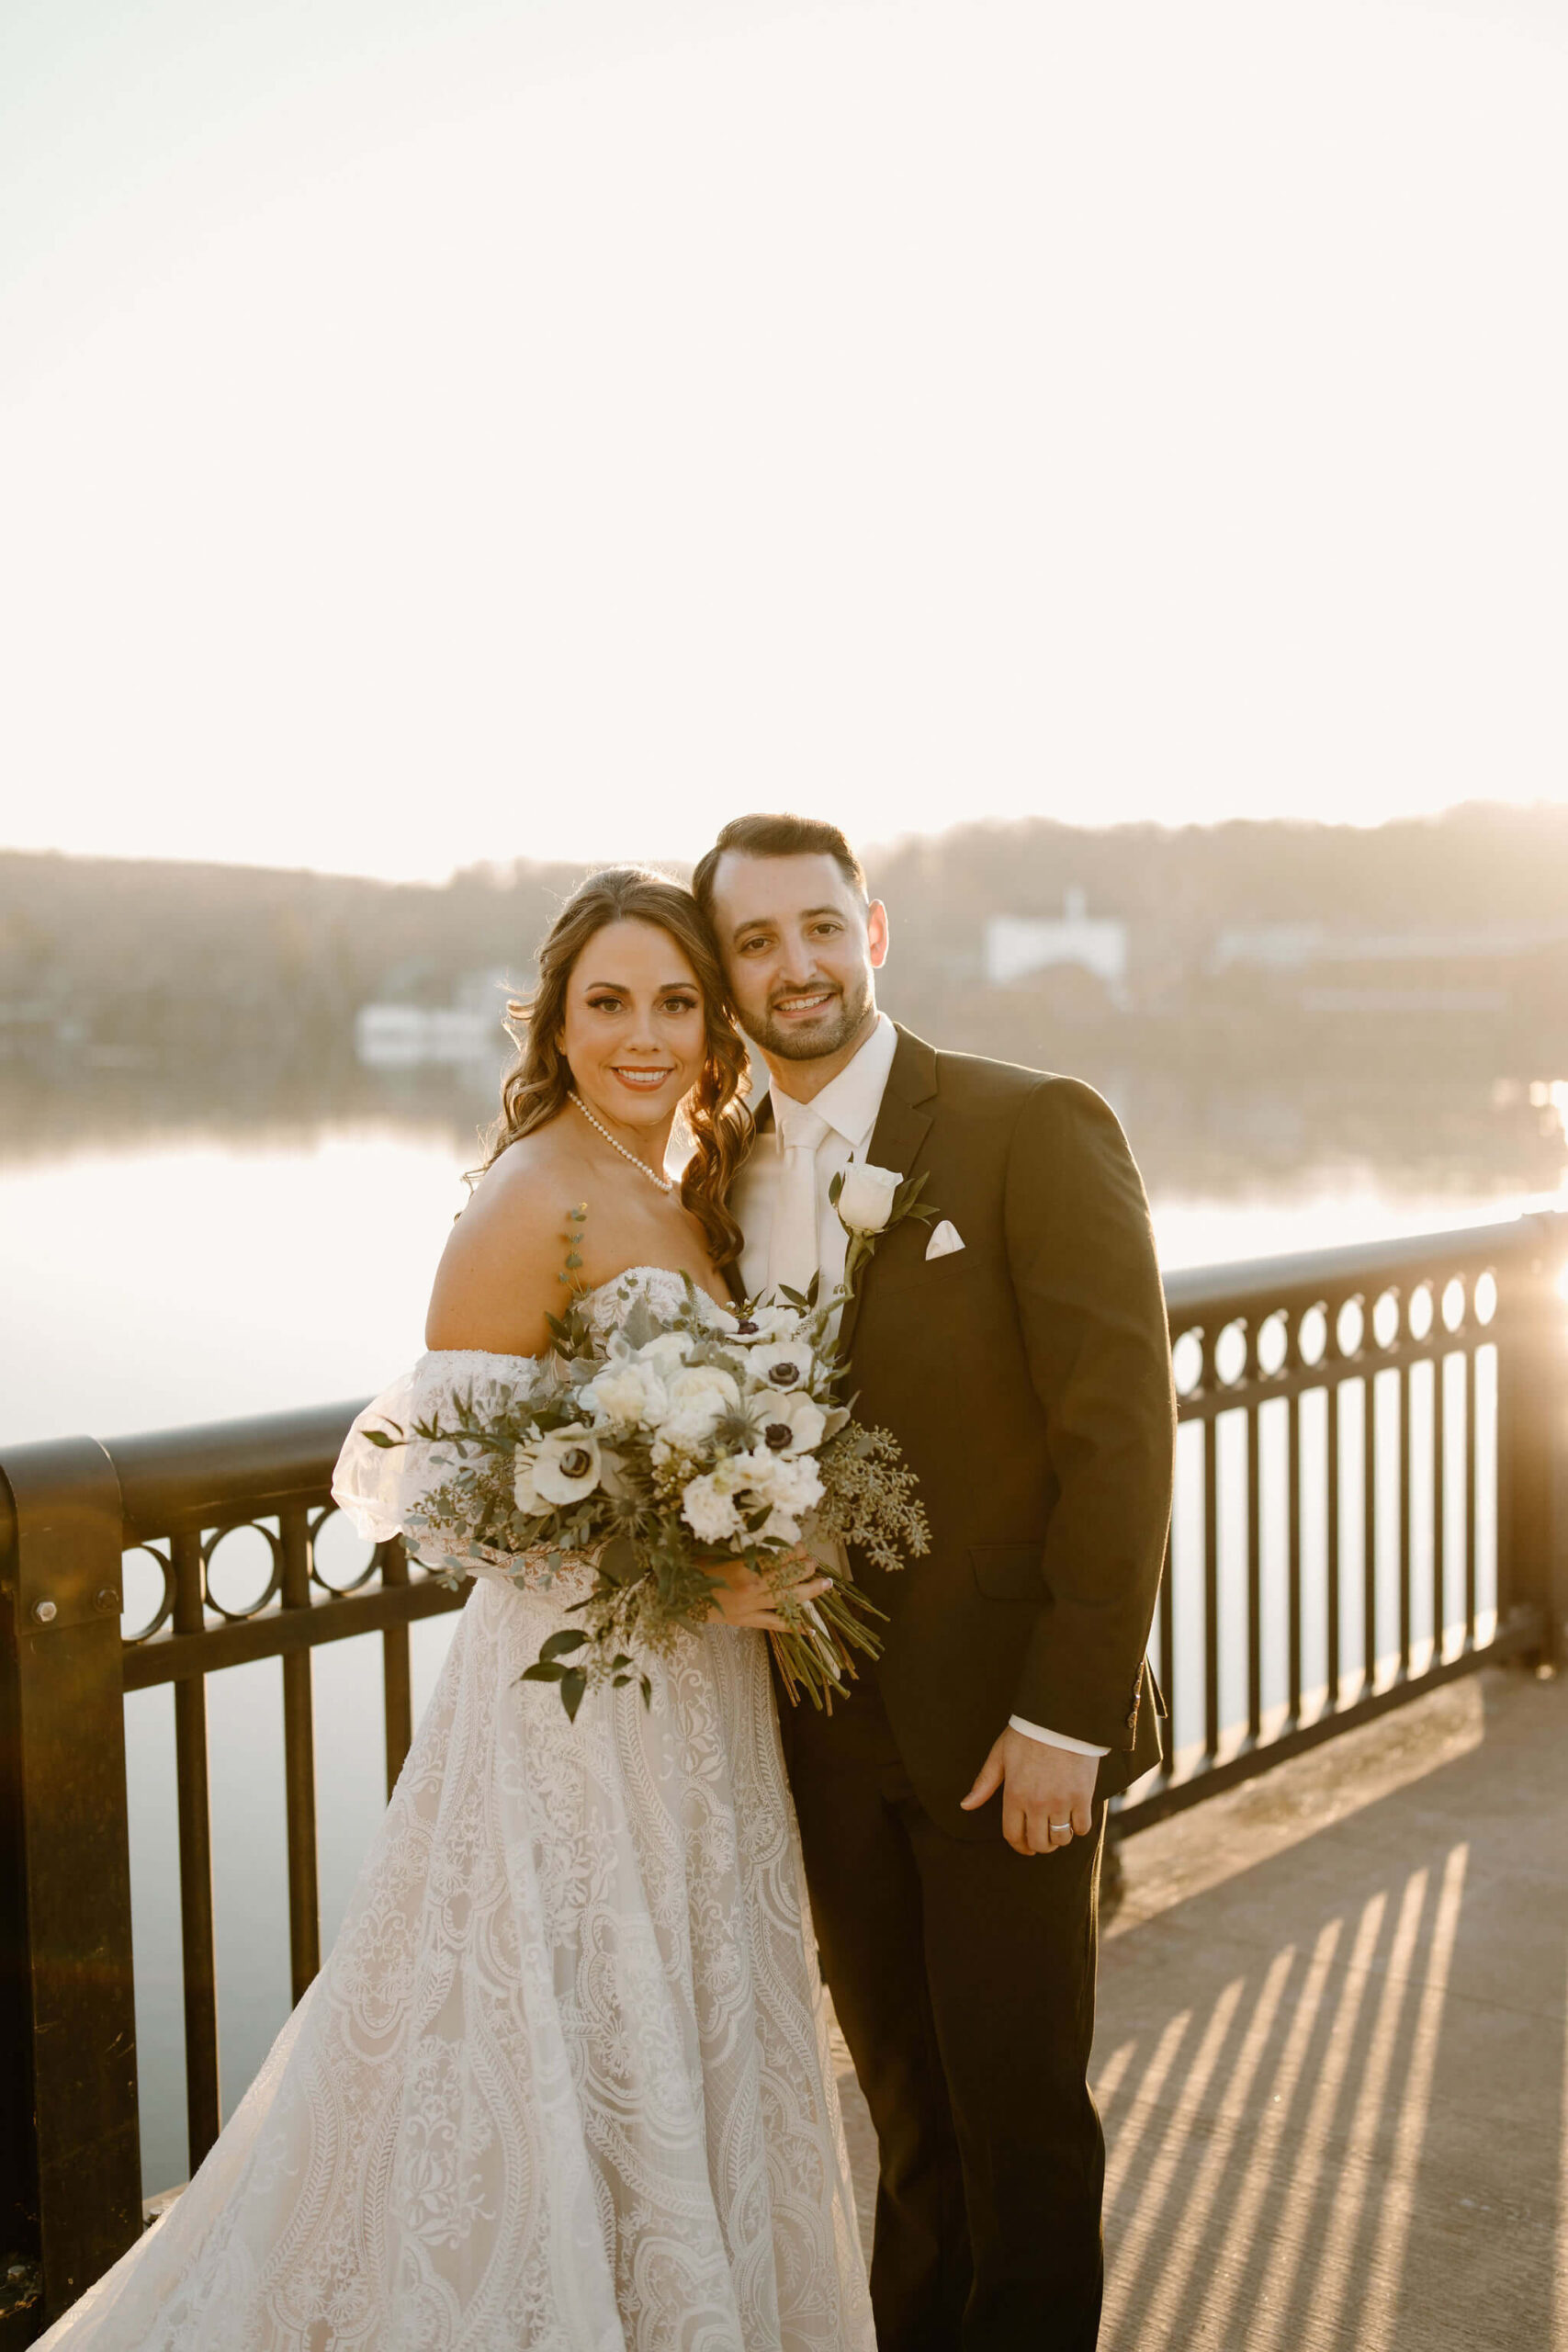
[712,849,886,1061]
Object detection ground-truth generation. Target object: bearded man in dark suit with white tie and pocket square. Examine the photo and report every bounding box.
[694,816,1173,2352]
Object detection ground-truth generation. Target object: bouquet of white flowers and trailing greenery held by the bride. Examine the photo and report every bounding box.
[365,1169,931,1717]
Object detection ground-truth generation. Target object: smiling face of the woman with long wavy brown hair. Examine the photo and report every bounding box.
[562,920,707,1126]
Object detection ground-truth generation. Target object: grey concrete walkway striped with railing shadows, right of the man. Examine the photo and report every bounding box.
[827,1670,1568,2352]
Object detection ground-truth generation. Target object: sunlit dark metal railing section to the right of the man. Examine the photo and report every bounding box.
[1122,1214,1568,1830]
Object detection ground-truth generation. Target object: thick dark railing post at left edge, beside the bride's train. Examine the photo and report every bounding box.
[0,1437,141,2343]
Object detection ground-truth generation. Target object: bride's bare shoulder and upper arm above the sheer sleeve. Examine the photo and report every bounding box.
[425,1122,588,1355]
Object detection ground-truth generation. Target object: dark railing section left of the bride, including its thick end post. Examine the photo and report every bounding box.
[0,1404,463,2345]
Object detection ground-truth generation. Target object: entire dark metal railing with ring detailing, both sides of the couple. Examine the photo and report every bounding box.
[0,1216,1568,2347]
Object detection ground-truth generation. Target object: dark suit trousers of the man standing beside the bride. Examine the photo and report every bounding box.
[792,1687,1105,2352]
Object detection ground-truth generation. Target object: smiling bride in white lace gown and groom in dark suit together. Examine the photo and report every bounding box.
[33,816,1173,2352]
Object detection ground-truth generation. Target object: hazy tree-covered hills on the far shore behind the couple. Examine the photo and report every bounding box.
[0,805,1568,1084]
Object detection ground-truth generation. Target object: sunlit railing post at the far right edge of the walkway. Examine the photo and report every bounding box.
[1497,1216,1568,1668]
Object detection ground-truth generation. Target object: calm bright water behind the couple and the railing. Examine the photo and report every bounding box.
[0,1114,1540,2189]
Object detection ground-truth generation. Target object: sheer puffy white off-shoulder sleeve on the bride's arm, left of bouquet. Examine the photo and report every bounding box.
[332,1348,557,1585]
